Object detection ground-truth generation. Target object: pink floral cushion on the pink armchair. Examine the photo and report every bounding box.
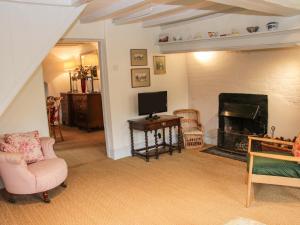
[4,131,44,163]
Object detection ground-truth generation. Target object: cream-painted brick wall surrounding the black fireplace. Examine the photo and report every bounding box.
[187,48,300,144]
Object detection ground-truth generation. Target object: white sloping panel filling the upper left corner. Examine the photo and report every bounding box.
[0,1,84,116]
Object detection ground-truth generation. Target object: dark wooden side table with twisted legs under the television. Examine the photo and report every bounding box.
[128,115,182,162]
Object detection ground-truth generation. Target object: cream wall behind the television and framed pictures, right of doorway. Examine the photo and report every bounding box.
[106,22,188,158]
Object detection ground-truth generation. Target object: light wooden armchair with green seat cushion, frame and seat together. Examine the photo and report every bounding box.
[246,137,300,207]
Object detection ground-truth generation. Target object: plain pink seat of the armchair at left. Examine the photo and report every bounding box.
[28,158,68,192]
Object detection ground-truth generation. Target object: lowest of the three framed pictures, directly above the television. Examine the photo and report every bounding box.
[131,68,150,88]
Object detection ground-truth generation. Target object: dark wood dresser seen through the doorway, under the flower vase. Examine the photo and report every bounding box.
[61,93,103,131]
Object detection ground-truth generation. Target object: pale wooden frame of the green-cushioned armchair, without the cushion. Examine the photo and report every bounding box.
[246,137,300,207]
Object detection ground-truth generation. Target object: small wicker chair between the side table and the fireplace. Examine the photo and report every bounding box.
[174,109,204,149]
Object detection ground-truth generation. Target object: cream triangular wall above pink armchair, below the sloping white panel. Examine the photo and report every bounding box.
[0,67,49,136]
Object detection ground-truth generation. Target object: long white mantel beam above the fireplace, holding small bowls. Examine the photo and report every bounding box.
[157,27,300,53]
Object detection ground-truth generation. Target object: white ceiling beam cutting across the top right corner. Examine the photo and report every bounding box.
[207,0,300,16]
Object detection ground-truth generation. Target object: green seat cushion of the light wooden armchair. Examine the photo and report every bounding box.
[248,153,300,178]
